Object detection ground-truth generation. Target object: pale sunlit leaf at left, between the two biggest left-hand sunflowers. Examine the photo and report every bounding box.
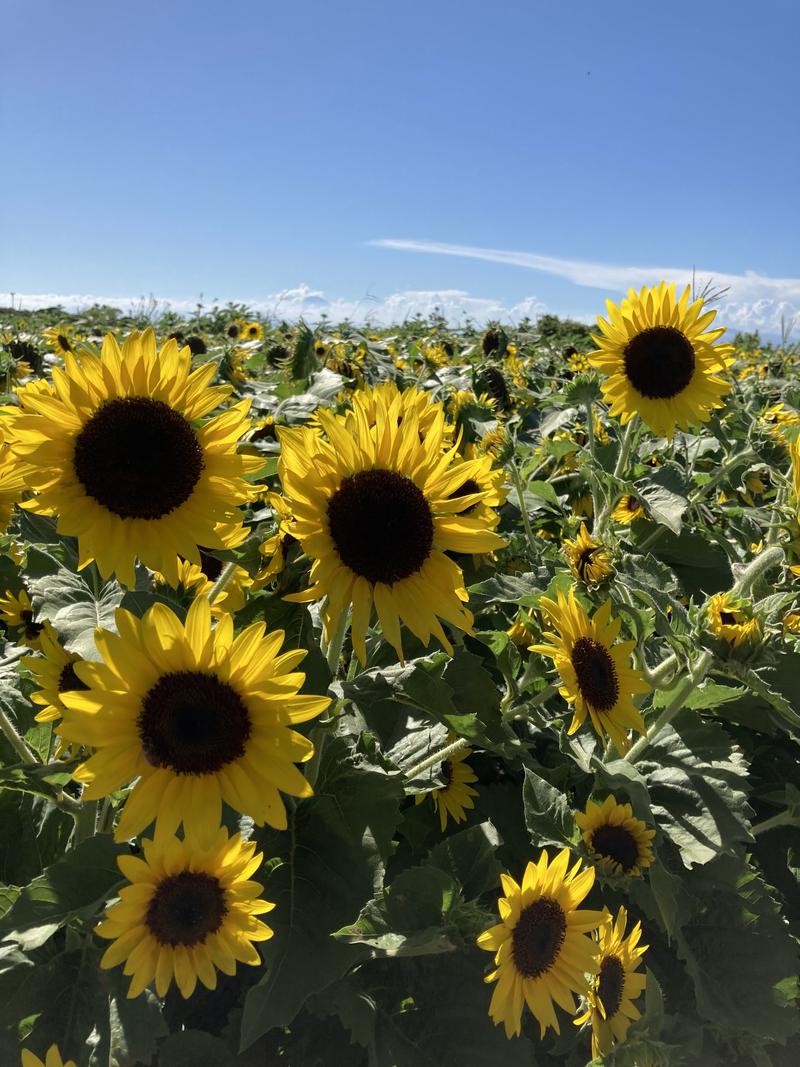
[28,548,125,659]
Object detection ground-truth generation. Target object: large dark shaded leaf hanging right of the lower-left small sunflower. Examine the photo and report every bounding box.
[236,737,402,1049]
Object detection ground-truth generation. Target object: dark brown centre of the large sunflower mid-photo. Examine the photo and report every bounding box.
[327,471,433,585]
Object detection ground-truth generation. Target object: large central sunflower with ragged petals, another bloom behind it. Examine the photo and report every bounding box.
[278,391,503,663]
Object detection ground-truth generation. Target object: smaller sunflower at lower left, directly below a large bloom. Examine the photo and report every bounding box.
[97,827,275,998]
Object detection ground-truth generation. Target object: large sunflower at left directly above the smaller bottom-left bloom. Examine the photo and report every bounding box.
[59,598,331,841]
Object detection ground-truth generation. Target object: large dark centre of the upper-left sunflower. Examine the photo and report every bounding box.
[73,397,205,519]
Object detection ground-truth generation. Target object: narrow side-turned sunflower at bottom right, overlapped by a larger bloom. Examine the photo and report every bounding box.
[575,908,647,1060]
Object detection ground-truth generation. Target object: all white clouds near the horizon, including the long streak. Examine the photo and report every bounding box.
[6,239,800,336]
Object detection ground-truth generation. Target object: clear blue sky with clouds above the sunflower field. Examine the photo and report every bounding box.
[0,0,800,329]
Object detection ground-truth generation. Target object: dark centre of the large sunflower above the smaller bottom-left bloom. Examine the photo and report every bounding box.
[137,670,251,775]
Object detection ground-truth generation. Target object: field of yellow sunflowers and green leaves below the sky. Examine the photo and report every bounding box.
[0,282,800,1067]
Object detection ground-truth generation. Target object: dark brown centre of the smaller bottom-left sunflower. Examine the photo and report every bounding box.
[145,871,228,947]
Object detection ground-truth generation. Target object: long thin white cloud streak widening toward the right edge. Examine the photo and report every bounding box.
[367,239,800,333]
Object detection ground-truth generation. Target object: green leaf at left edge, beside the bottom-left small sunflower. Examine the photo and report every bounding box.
[0,834,126,949]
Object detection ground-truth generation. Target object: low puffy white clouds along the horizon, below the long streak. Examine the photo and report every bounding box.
[0,285,546,325]
